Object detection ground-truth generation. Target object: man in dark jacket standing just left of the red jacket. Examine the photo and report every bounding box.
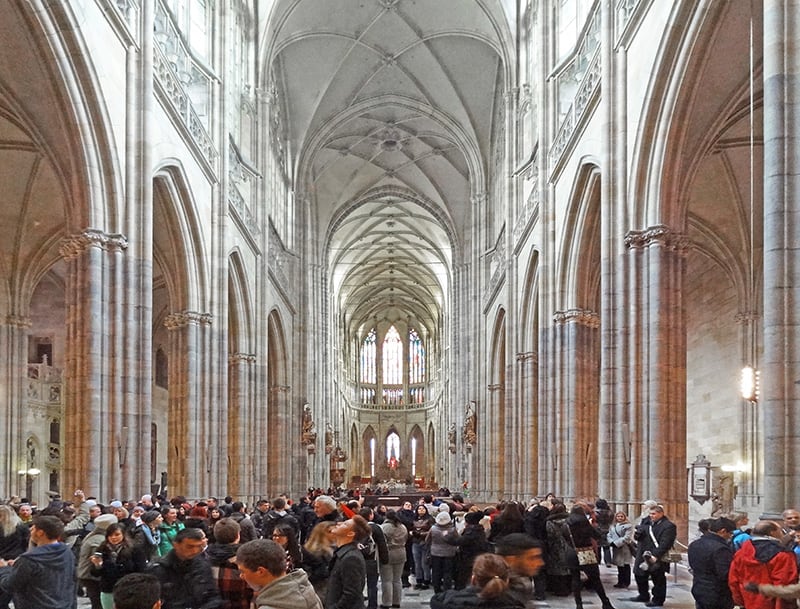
[689,518,736,609]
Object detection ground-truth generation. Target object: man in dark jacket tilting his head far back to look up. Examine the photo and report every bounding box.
[325,516,370,609]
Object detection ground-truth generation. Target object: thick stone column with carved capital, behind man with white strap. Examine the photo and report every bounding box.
[619,225,688,534]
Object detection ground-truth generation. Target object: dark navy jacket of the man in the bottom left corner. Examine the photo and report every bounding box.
[0,542,78,609]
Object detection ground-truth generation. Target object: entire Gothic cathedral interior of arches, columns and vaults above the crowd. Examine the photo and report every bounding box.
[0,0,800,531]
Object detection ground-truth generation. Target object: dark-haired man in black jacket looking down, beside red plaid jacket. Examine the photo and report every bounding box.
[149,527,222,609]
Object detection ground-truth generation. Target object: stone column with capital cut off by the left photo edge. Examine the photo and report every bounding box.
[0,315,31,497]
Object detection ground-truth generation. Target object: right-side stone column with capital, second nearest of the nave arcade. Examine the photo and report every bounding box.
[547,309,600,497]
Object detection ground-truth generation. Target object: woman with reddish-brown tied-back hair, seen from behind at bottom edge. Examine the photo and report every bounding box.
[431,554,525,609]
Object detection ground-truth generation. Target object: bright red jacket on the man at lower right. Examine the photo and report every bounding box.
[728,537,797,609]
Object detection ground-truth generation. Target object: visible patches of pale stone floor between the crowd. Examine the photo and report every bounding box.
[78,564,694,609]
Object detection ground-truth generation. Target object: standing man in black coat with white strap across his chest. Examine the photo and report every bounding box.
[630,505,678,607]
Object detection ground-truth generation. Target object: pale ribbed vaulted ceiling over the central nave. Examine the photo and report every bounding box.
[267,0,512,338]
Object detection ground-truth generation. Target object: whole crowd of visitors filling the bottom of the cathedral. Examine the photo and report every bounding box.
[0,489,800,609]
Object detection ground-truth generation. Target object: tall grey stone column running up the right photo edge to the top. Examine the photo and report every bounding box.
[760,0,800,513]
